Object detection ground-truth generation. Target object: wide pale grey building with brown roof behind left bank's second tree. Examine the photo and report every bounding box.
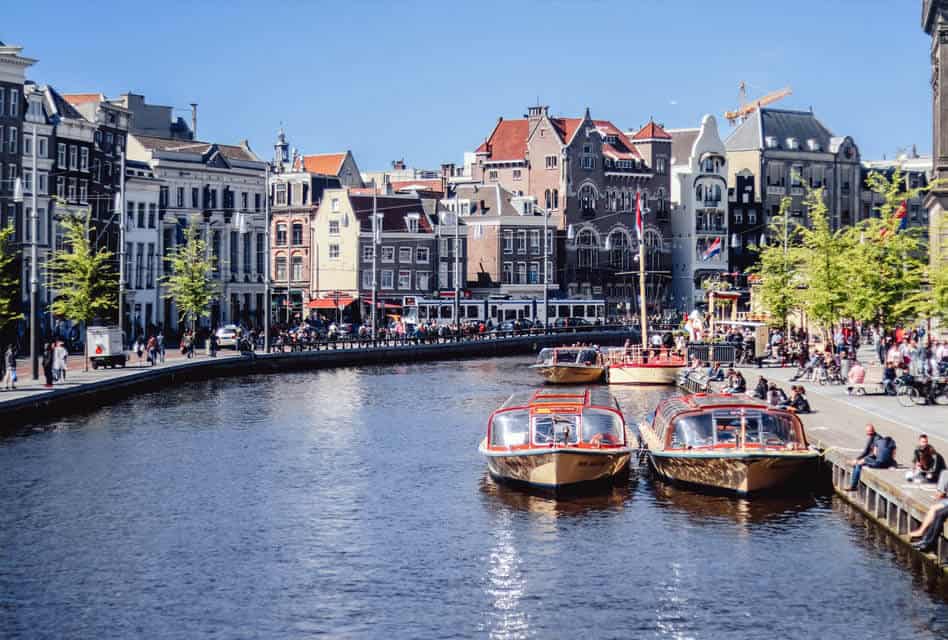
[128,135,267,330]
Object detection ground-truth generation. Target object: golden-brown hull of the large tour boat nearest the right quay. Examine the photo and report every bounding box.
[648,451,819,494]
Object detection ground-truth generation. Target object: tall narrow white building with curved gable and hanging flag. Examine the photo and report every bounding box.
[669,115,728,311]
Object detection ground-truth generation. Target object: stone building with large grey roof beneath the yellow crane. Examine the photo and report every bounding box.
[725,108,862,229]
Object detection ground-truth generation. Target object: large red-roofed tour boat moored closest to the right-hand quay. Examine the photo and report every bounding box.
[639,393,819,494]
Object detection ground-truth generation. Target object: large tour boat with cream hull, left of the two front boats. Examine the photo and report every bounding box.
[478,389,632,490]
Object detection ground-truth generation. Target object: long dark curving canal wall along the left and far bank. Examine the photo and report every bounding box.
[0,330,630,430]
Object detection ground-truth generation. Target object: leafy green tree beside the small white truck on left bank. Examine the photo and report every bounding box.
[46,209,118,367]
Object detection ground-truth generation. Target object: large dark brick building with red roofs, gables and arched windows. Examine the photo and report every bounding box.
[471,106,671,313]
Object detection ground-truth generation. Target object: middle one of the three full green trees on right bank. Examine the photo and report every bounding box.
[798,188,853,338]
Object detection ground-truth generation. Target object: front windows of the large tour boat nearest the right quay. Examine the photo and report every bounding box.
[669,409,803,449]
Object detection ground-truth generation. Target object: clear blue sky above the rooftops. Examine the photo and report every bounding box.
[0,0,931,170]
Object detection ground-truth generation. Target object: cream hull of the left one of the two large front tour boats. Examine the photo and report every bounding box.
[481,447,632,489]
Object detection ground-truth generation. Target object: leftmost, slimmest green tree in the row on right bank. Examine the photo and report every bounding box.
[751,197,800,327]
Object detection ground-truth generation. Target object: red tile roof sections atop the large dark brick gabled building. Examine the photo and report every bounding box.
[477,118,640,161]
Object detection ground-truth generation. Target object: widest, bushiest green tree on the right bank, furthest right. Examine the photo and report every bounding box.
[846,169,937,329]
